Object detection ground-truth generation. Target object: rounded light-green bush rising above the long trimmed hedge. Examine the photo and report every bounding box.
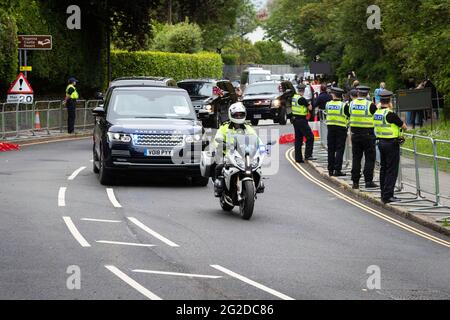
[152,21,203,53]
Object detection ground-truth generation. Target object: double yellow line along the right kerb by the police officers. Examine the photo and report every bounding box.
[286,148,450,248]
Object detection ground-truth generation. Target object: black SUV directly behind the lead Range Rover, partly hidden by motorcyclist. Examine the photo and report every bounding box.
[178,79,238,129]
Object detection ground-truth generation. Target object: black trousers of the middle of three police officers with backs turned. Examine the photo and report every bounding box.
[352,133,377,183]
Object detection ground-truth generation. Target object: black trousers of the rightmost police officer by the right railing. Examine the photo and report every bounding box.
[378,139,400,200]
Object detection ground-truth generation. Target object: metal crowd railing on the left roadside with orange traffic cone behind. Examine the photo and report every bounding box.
[0,100,101,139]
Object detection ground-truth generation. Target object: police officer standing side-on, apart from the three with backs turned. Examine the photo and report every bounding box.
[291,84,316,163]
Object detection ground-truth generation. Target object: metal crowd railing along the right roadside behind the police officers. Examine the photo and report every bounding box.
[320,112,450,222]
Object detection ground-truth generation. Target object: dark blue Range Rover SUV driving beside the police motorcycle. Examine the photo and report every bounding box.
[93,79,208,186]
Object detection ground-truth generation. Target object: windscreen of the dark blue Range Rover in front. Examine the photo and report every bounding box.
[108,89,195,121]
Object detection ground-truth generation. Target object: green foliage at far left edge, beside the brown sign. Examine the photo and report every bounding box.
[0,8,17,93]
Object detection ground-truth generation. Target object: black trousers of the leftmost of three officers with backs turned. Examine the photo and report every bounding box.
[327,126,347,172]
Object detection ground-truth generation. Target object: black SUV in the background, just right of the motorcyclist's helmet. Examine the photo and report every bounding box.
[242,81,295,126]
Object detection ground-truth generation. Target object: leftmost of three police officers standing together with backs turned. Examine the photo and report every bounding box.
[325,87,348,177]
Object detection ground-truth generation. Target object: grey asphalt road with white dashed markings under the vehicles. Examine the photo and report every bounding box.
[0,126,450,300]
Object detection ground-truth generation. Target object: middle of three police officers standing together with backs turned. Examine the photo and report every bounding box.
[345,86,378,189]
